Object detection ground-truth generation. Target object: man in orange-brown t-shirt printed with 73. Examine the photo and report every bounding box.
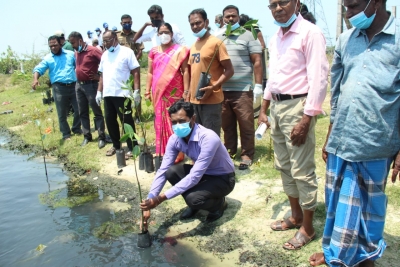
[188,8,234,136]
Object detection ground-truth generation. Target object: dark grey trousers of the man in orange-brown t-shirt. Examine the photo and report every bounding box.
[193,103,222,136]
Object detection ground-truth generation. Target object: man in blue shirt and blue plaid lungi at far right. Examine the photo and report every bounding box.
[309,0,400,267]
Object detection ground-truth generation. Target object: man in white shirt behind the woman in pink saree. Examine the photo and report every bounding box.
[133,5,186,47]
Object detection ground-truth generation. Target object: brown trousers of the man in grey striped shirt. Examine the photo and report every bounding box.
[222,91,255,159]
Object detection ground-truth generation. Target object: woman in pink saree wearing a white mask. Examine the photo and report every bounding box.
[144,22,190,163]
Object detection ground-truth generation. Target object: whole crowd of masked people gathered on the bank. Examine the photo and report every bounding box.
[32,0,400,267]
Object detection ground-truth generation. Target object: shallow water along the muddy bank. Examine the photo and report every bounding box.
[0,137,222,267]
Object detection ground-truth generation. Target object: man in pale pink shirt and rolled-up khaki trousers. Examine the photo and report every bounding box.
[259,0,328,250]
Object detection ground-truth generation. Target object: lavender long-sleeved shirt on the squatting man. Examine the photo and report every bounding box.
[148,123,235,199]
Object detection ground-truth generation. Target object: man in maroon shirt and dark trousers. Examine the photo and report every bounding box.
[68,32,106,148]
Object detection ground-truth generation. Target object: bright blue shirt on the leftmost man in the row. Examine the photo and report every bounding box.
[33,49,76,84]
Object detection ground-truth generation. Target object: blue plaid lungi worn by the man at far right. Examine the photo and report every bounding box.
[322,154,393,267]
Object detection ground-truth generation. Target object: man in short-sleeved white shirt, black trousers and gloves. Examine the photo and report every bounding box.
[96,31,141,158]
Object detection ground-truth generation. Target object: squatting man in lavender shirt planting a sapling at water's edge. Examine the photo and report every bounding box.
[140,100,235,228]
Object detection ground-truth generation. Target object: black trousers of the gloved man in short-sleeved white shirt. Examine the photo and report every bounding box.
[104,96,137,151]
